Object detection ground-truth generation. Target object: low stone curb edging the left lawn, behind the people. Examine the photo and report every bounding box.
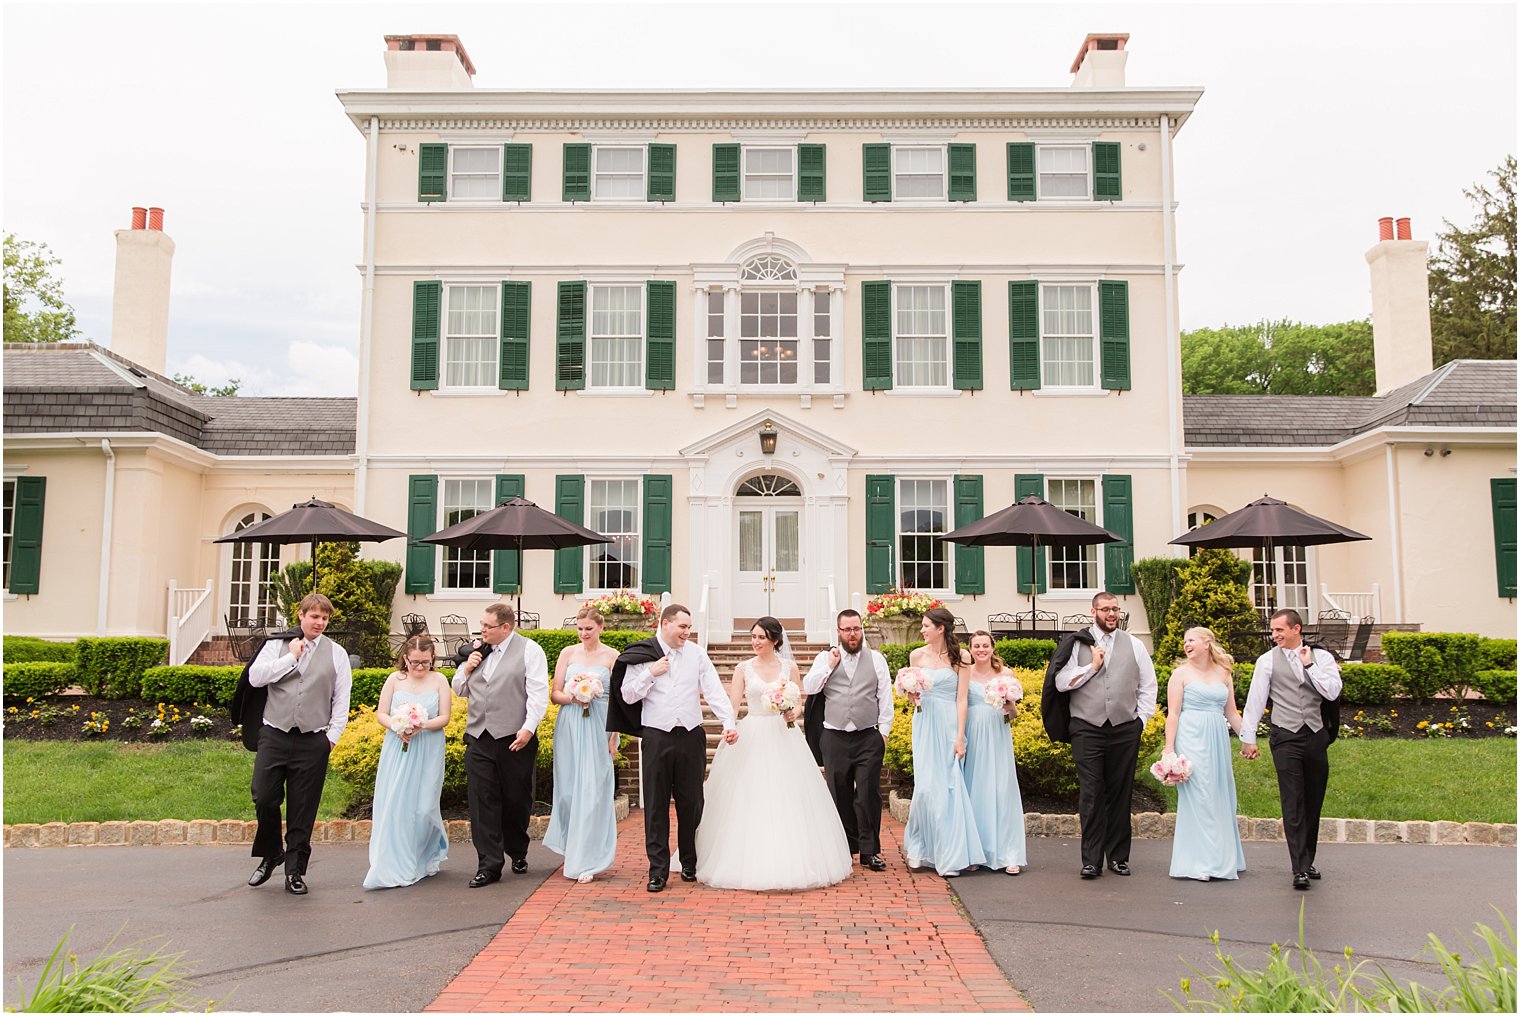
[5,794,629,847]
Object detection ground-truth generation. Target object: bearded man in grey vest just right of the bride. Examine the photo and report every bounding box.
[803,610,892,872]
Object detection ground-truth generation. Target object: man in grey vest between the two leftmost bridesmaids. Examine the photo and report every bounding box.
[451,604,549,888]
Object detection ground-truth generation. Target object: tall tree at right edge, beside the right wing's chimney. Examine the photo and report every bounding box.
[1430,155,1515,367]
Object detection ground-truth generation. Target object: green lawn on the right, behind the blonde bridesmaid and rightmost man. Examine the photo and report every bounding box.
[1152,738,1515,823]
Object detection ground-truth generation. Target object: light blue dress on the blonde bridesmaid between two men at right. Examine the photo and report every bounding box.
[1172,681,1245,879]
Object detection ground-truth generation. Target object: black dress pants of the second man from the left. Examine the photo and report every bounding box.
[465,732,538,875]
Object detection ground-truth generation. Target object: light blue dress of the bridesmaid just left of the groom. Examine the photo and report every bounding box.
[544,663,617,879]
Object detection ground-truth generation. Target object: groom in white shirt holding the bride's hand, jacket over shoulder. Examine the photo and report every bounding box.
[606,604,739,893]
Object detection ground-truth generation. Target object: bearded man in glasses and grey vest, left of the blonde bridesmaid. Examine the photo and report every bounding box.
[1055,593,1155,879]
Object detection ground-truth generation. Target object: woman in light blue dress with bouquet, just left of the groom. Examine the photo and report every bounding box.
[544,607,617,884]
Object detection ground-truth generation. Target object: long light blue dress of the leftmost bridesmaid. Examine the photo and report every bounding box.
[365,691,448,888]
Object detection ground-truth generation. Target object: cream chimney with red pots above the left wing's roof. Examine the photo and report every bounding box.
[111,208,175,374]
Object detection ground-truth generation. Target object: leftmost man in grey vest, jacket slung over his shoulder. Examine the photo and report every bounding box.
[248,593,353,896]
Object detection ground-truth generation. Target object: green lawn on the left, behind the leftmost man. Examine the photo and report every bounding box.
[5,741,348,824]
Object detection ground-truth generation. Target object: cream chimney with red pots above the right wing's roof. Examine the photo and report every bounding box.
[1366,217,1433,395]
